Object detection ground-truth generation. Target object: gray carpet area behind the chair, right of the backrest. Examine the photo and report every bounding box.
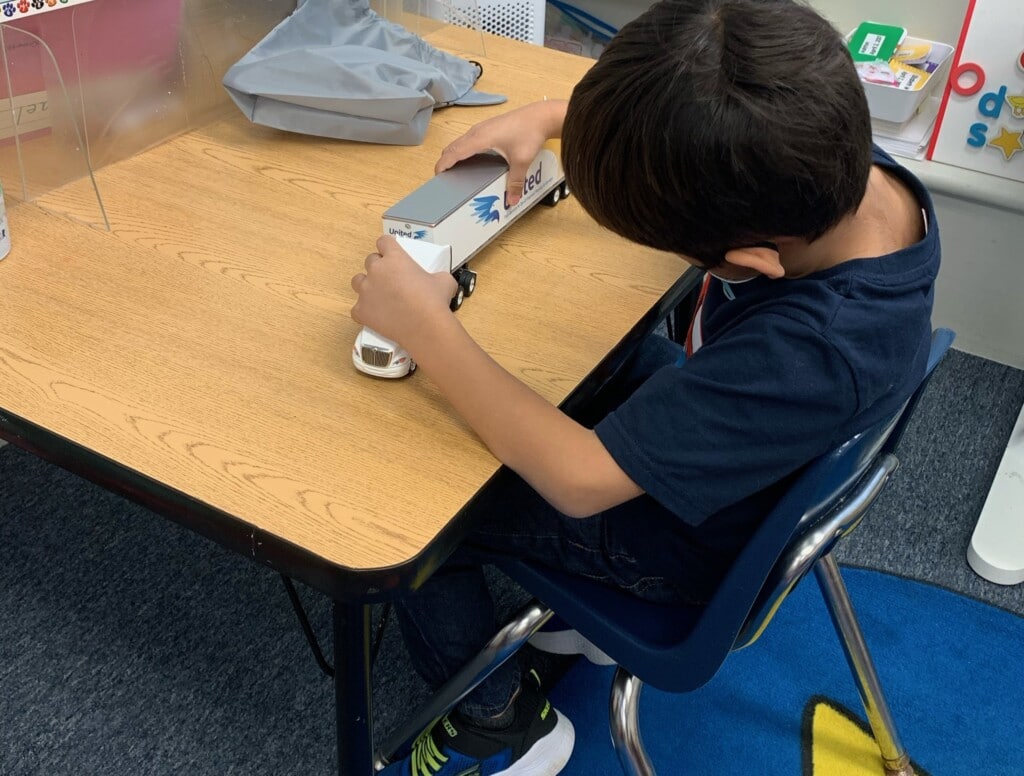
[836,350,1024,615]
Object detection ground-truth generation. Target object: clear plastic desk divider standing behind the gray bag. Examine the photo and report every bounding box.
[0,0,485,237]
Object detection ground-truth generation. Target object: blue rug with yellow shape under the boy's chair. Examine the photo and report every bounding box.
[552,568,1024,776]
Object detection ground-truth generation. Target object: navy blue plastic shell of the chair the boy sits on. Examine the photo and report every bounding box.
[505,330,953,692]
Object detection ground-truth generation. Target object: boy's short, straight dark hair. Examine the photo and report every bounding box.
[562,0,871,267]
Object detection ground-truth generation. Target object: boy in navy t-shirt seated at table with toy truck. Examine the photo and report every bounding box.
[352,0,939,776]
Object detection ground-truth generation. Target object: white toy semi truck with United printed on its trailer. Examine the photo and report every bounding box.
[352,148,568,378]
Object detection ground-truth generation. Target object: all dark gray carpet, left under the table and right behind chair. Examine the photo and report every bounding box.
[0,351,1024,776]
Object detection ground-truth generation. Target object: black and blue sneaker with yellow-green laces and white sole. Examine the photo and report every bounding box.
[381,681,575,776]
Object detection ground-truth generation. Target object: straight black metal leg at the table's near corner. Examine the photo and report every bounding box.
[334,601,374,776]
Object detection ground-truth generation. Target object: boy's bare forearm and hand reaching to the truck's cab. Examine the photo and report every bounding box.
[352,236,643,517]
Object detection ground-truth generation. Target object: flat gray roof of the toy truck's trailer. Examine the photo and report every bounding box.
[384,154,509,226]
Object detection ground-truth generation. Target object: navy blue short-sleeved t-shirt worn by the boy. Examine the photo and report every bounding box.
[596,148,939,597]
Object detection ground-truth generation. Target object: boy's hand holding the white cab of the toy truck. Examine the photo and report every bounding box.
[351,234,456,348]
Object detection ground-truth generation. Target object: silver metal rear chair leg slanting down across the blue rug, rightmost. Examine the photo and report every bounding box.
[814,553,914,776]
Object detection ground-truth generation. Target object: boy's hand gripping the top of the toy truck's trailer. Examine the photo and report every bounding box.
[434,99,567,205]
